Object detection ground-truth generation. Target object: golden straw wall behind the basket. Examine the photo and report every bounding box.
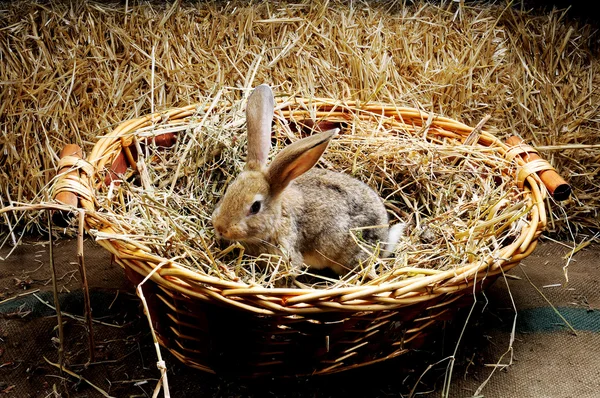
[0,1,600,239]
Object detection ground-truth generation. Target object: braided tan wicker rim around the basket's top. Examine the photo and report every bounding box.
[69,97,551,315]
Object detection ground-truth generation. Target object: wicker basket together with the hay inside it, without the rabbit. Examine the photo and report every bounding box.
[55,92,549,376]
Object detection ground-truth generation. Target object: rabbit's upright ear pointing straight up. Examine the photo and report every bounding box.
[246,84,275,170]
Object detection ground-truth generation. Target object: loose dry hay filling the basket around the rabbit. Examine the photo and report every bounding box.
[81,90,531,288]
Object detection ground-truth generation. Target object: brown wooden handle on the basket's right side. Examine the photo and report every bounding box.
[506,136,571,201]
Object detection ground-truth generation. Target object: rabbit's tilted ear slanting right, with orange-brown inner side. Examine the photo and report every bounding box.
[267,129,339,196]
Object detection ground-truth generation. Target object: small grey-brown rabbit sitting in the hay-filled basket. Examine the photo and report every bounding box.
[211,84,405,278]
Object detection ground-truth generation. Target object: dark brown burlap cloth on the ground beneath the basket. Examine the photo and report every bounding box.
[0,240,600,398]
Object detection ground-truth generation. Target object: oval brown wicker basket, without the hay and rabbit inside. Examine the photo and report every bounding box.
[54,99,552,377]
